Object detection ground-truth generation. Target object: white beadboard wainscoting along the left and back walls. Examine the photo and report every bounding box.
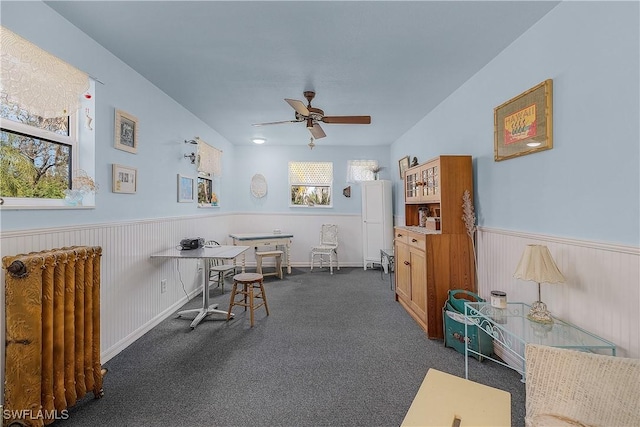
[0,214,362,401]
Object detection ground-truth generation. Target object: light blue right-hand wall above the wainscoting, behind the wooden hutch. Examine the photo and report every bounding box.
[391,2,640,246]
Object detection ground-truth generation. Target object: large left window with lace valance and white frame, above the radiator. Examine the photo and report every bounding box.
[0,26,97,209]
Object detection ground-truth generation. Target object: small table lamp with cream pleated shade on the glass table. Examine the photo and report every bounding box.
[513,245,565,323]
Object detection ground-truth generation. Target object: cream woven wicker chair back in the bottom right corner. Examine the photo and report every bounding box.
[525,344,640,427]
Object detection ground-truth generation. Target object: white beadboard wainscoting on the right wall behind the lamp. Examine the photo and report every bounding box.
[477,227,640,362]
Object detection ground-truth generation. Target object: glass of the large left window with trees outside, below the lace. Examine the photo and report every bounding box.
[0,94,72,199]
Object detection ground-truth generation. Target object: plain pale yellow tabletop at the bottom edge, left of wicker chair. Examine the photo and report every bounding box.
[402,369,511,427]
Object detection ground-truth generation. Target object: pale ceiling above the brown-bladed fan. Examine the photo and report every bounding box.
[46,1,559,145]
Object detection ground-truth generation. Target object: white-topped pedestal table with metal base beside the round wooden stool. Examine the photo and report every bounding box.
[151,246,249,329]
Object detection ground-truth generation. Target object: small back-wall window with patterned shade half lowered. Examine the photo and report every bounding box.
[289,162,333,208]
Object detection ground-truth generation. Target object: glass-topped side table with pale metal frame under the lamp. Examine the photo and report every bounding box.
[464,302,616,381]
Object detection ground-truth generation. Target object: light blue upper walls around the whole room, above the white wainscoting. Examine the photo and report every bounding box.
[0,2,640,246]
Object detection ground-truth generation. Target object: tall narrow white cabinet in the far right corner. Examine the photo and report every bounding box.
[361,180,393,270]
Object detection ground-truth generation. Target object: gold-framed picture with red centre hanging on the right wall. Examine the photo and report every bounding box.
[493,79,553,162]
